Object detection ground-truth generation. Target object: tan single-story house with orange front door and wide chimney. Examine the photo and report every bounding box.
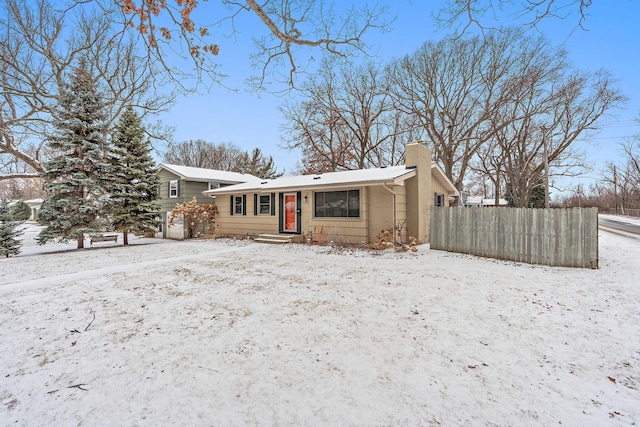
[204,143,458,243]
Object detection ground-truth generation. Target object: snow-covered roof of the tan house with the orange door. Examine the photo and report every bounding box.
[204,166,416,195]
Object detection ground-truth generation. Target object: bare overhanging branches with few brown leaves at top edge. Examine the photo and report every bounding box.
[113,0,388,89]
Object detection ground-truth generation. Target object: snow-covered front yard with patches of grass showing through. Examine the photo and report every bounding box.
[0,221,640,426]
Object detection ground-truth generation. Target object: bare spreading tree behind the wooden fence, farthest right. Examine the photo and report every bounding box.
[495,66,625,207]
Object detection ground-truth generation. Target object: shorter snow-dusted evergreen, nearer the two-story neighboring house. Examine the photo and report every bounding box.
[108,106,160,245]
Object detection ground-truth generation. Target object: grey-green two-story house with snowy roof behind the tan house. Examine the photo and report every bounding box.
[156,163,260,239]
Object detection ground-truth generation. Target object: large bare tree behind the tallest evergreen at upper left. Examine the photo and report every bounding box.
[0,0,173,180]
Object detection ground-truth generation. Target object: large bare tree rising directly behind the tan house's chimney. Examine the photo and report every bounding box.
[389,29,526,189]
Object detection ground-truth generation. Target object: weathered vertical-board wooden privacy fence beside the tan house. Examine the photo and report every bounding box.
[430,207,598,268]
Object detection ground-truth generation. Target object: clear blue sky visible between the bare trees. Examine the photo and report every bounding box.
[154,0,640,194]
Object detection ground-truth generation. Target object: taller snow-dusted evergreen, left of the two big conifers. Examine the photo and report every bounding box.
[38,59,109,249]
